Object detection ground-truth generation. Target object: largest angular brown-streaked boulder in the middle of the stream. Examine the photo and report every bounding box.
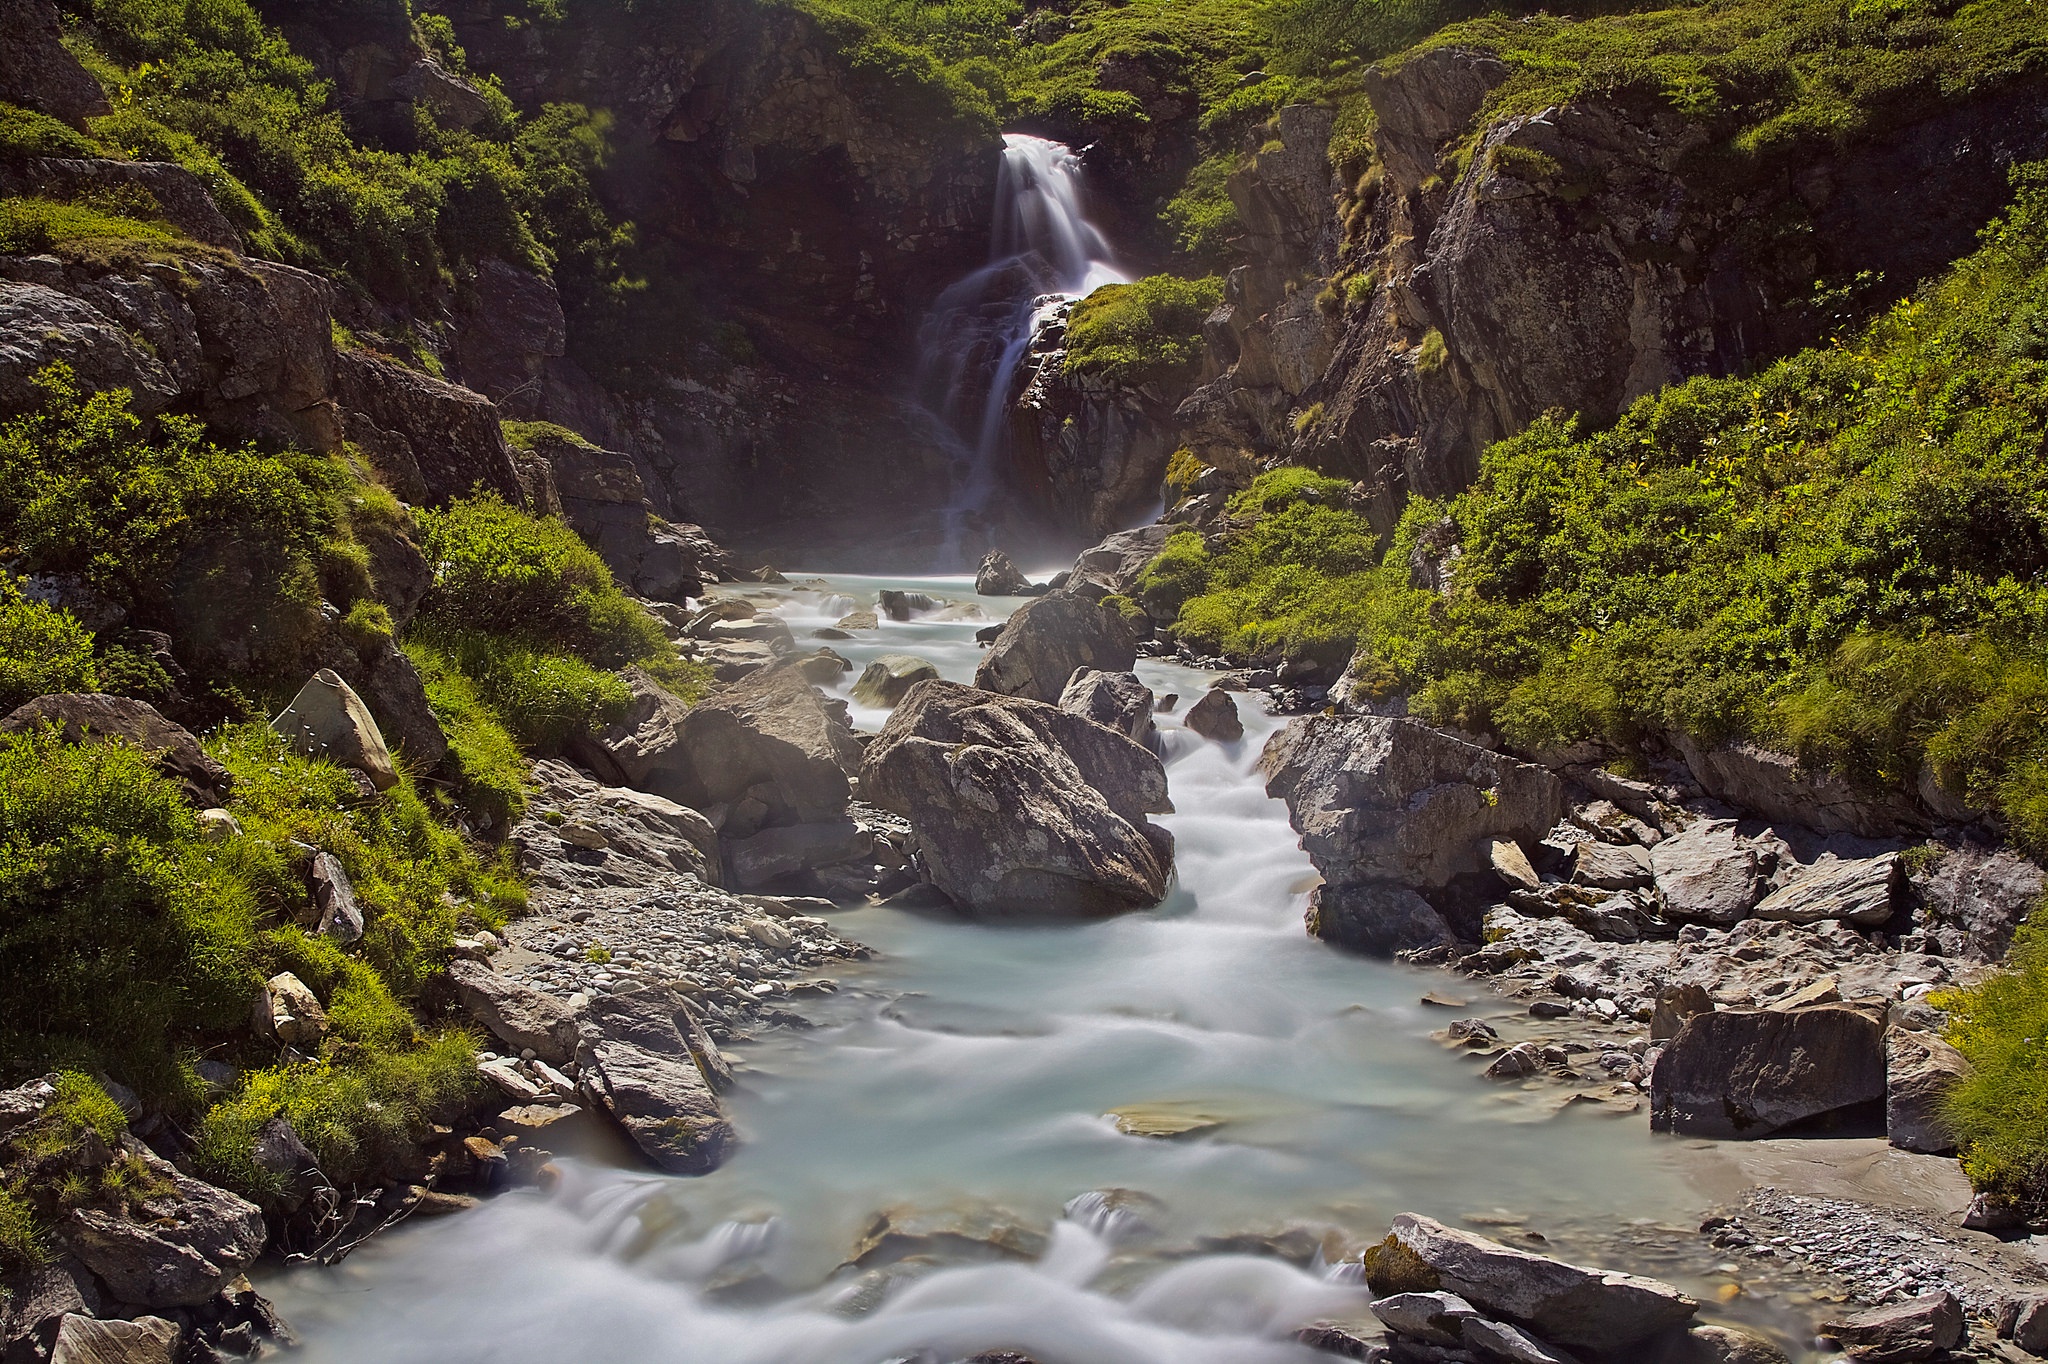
[860,682,1174,913]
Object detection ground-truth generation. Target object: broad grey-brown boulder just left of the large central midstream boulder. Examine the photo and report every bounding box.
[575,668,860,823]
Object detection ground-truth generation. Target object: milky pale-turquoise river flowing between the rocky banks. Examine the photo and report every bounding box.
[266,578,1818,1364]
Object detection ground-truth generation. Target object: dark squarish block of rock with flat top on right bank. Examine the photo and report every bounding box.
[1651,1004,1884,1139]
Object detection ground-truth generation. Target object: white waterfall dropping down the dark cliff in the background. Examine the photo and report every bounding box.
[918,133,1128,567]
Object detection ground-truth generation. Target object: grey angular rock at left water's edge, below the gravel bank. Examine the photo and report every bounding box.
[575,989,737,1174]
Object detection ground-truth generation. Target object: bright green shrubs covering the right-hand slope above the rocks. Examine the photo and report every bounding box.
[1145,168,2048,850]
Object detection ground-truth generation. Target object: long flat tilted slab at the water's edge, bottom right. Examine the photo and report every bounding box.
[1366,1212,1700,1350]
